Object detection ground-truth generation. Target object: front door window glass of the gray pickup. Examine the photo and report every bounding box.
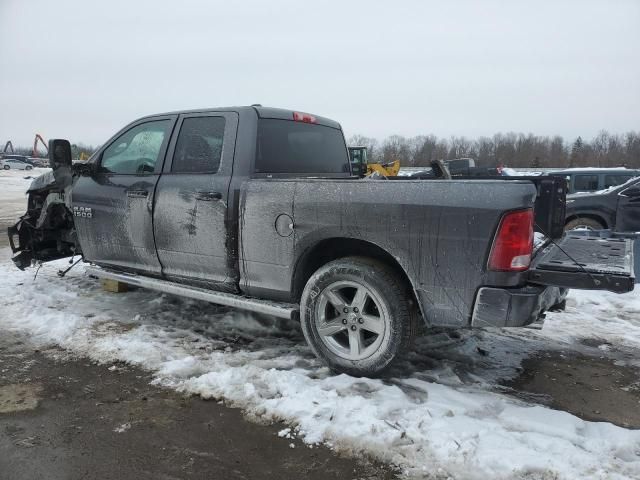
[100,120,171,175]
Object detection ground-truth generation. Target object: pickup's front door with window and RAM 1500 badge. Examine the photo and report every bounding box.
[72,115,177,274]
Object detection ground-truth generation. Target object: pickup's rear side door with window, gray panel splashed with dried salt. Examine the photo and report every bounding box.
[154,112,238,288]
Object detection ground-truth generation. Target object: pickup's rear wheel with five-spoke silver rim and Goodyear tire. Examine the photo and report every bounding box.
[300,257,417,376]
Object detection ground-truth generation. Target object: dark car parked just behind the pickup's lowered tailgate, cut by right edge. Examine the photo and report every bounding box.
[565,178,640,232]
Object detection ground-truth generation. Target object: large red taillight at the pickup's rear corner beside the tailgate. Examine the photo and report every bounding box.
[489,209,533,272]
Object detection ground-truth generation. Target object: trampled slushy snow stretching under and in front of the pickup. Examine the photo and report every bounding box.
[0,255,640,479]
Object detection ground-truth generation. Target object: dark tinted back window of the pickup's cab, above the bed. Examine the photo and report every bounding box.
[255,118,350,174]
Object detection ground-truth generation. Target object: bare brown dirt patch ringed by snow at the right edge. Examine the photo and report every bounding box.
[508,352,640,428]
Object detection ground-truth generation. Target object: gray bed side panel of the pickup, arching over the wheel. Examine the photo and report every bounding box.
[241,179,536,326]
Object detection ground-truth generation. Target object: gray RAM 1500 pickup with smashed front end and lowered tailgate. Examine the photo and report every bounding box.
[9,106,634,375]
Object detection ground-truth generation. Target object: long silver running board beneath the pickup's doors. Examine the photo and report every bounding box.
[86,266,300,319]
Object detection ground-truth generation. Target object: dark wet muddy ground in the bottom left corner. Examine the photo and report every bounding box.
[0,332,395,480]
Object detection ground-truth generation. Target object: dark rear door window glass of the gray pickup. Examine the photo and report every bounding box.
[171,117,225,173]
